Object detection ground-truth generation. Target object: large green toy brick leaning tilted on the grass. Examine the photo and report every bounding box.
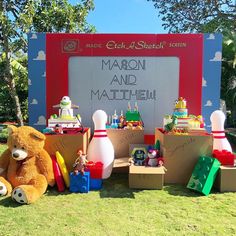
[187,156,220,195]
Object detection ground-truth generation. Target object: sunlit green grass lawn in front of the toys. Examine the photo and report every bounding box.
[0,147,236,236]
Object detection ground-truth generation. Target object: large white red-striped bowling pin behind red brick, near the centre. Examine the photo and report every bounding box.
[87,110,115,179]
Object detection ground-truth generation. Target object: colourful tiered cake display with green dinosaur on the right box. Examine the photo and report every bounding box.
[163,97,205,134]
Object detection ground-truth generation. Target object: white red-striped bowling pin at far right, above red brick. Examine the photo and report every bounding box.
[210,110,232,152]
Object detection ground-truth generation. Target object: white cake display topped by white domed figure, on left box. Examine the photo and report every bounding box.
[43,96,83,134]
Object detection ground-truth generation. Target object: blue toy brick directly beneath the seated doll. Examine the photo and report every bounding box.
[70,172,90,193]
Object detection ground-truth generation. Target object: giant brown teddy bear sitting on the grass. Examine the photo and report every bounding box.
[0,126,55,204]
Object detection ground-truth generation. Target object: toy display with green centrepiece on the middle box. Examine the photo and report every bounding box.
[106,103,144,130]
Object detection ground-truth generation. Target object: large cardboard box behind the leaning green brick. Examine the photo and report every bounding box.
[155,129,213,185]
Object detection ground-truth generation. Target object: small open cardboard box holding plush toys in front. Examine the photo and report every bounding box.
[129,165,165,189]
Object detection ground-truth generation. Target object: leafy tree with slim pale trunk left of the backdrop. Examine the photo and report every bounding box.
[0,0,95,125]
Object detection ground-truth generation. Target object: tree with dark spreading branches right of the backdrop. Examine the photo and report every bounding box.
[147,0,236,124]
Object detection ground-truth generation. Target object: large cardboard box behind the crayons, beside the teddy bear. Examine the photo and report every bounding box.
[44,128,90,171]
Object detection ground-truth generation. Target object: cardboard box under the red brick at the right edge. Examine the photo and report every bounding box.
[214,166,236,192]
